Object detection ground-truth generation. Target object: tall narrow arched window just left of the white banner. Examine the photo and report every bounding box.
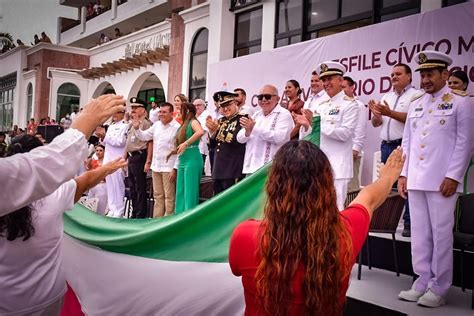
[188,29,209,100]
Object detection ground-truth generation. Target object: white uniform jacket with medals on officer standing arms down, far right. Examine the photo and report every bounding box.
[401,85,472,192]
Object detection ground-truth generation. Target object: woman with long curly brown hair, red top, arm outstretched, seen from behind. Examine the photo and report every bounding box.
[229,141,403,316]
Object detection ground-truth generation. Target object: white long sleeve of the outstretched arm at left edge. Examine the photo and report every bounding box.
[0,128,87,216]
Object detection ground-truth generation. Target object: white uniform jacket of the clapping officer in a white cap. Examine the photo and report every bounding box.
[320,91,359,180]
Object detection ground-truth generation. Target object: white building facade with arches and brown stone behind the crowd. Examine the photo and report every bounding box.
[0,0,466,131]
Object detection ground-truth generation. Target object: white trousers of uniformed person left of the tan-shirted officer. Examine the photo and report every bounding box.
[105,169,125,217]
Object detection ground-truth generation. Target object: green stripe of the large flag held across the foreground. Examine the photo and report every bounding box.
[64,117,320,262]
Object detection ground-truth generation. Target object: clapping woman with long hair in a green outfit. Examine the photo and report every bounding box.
[175,102,204,214]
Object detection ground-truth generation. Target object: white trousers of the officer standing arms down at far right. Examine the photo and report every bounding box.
[408,190,458,296]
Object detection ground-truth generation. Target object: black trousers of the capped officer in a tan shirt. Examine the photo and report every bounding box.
[128,151,148,218]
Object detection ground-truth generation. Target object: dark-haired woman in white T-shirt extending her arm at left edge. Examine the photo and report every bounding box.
[0,135,125,315]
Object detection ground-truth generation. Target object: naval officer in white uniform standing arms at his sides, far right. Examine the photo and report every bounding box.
[398,51,473,307]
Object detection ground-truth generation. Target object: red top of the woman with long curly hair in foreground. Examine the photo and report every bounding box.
[229,204,370,315]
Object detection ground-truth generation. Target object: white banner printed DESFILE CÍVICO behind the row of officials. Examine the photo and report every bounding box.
[208,3,474,184]
